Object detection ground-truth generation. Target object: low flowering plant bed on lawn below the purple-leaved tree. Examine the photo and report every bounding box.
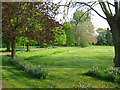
[10,59,48,79]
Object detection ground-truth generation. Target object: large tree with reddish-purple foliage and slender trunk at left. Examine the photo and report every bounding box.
[2,2,61,59]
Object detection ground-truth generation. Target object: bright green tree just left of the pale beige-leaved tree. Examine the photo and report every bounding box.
[63,22,75,46]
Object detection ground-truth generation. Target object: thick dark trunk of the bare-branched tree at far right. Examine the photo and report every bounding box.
[109,19,120,67]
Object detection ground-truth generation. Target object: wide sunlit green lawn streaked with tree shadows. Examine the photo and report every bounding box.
[2,46,120,88]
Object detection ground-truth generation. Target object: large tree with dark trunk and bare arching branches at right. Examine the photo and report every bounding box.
[64,0,120,67]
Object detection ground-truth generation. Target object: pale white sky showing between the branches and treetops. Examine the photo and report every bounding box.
[56,0,113,30]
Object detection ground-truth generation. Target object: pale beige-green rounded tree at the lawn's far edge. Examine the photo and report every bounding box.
[75,20,96,47]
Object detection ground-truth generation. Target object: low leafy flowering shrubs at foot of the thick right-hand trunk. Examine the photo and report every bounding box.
[86,67,120,83]
